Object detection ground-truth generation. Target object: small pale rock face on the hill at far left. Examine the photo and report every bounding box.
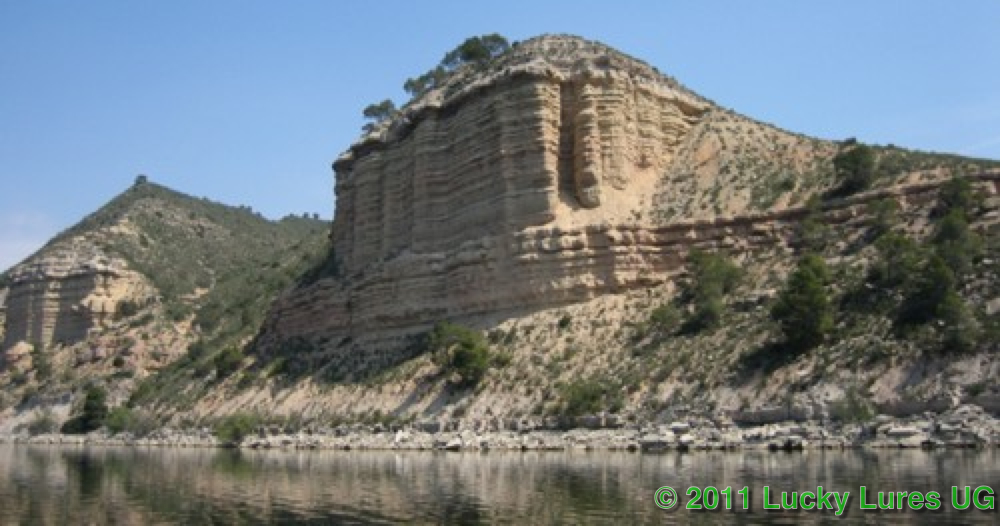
[3,239,151,356]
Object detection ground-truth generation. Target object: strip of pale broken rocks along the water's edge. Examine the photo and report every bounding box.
[0,404,1000,453]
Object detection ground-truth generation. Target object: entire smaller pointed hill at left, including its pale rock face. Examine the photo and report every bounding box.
[0,177,329,432]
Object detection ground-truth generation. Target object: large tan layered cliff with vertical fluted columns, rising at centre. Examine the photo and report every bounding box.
[261,36,834,368]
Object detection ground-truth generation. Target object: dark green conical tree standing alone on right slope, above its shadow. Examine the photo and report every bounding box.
[771,254,833,351]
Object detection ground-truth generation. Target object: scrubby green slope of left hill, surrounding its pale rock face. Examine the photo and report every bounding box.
[0,177,329,428]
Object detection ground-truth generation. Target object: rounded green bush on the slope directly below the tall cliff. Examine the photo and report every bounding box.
[428,322,491,385]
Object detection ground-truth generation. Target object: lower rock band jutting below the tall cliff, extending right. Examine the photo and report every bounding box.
[263,138,1000,374]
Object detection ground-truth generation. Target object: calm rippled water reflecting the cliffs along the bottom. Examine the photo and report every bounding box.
[0,445,1000,525]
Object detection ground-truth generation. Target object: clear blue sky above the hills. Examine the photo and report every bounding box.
[0,0,1000,268]
